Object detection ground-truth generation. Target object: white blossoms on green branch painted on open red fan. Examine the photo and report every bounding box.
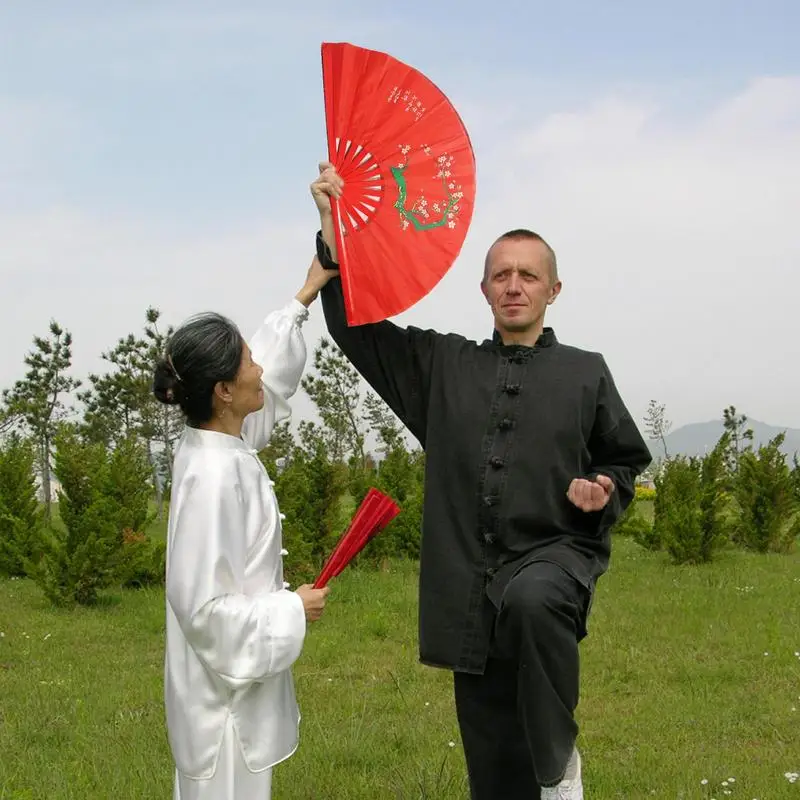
[391,144,464,231]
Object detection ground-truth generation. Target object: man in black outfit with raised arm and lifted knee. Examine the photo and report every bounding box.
[311,162,651,800]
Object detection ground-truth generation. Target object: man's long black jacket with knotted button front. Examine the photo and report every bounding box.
[317,235,651,673]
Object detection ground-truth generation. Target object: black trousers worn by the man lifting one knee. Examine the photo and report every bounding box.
[454,562,591,800]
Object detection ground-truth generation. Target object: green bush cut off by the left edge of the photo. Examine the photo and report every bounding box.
[0,435,42,577]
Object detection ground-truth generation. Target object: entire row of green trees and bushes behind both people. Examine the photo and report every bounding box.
[0,308,800,606]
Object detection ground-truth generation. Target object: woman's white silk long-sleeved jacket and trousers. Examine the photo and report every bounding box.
[165,300,308,800]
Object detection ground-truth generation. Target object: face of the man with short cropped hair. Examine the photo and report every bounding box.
[481,239,561,334]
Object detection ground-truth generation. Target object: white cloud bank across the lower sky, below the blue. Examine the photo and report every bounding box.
[0,77,800,438]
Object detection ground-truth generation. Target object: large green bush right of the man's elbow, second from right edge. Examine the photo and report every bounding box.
[654,447,727,564]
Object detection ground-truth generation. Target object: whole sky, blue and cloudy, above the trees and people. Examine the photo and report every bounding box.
[0,0,800,438]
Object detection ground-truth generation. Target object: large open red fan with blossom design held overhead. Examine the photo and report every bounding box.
[322,43,475,325]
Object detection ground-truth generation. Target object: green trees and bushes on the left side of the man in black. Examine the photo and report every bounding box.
[0,308,424,606]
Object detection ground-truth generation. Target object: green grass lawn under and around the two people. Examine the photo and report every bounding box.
[0,540,800,800]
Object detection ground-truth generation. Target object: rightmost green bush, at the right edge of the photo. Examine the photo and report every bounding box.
[733,434,800,553]
